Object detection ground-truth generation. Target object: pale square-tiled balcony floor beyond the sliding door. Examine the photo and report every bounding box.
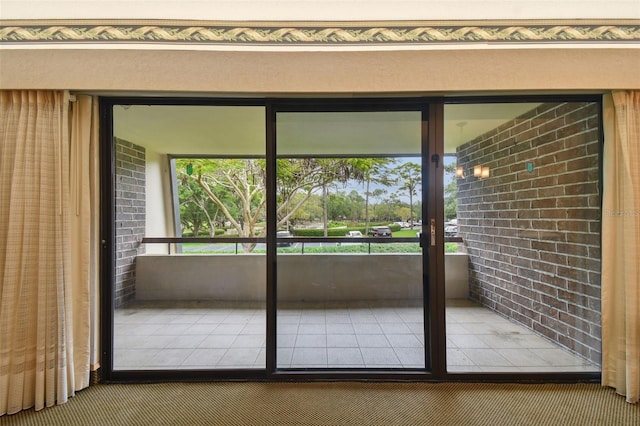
[114,301,599,372]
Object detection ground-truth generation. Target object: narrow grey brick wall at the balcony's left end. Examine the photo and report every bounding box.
[114,139,146,308]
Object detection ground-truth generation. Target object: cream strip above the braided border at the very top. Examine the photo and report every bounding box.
[1,0,640,21]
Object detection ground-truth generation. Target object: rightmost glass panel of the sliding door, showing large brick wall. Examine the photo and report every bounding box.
[444,102,601,373]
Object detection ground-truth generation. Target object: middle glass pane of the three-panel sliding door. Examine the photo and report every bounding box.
[275,110,425,370]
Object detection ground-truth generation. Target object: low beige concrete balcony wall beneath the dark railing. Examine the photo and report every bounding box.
[136,253,469,302]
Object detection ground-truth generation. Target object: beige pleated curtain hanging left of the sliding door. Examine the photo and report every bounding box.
[0,91,97,415]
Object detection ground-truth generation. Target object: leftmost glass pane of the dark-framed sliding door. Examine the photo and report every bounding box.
[113,105,266,372]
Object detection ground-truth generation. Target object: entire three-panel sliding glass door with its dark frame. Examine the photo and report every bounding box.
[101,97,602,380]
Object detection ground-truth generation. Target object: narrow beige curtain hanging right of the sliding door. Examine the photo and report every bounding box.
[602,91,640,403]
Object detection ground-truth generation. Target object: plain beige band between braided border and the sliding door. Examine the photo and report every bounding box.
[0,43,640,95]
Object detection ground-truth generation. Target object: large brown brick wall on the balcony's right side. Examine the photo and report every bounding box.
[457,103,601,363]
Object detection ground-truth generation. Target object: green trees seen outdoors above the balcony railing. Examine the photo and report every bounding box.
[175,158,430,252]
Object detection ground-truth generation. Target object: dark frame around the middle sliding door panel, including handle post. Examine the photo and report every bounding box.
[266,98,446,380]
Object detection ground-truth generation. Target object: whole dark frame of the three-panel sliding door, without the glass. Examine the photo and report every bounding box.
[100,95,601,382]
